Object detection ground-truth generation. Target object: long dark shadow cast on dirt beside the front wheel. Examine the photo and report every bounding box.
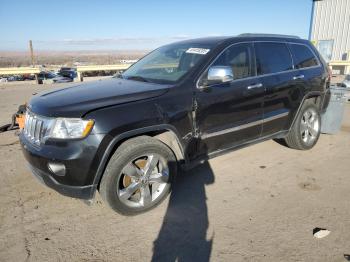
[152,162,214,261]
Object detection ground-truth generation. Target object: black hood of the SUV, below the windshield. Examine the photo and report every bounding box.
[28,78,170,117]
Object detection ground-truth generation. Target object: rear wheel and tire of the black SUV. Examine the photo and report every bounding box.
[284,101,321,150]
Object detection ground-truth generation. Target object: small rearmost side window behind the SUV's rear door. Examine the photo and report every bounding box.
[290,44,318,69]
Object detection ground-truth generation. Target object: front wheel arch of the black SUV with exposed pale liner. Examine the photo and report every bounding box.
[93,124,186,189]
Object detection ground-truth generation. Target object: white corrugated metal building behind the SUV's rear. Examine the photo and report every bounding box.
[309,0,350,74]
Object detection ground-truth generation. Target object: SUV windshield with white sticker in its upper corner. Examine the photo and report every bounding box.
[121,43,210,84]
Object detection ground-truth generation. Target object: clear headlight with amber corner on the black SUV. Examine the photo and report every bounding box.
[47,118,94,139]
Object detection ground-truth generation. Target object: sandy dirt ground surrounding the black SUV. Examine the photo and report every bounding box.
[0,85,350,261]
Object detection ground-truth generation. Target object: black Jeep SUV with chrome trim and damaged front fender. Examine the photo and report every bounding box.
[20,34,330,215]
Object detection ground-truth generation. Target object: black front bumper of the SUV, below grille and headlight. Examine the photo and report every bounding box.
[19,134,103,199]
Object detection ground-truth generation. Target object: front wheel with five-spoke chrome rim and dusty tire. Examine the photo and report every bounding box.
[99,136,177,215]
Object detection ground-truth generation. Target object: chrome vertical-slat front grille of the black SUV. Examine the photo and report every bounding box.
[23,111,45,145]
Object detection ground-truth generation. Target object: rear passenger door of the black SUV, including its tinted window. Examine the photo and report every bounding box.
[254,42,300,136]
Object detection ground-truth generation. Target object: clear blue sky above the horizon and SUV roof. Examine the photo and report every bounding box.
[0,0,312,51]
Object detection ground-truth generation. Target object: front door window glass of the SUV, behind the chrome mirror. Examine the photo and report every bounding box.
[212,44,253,79]
